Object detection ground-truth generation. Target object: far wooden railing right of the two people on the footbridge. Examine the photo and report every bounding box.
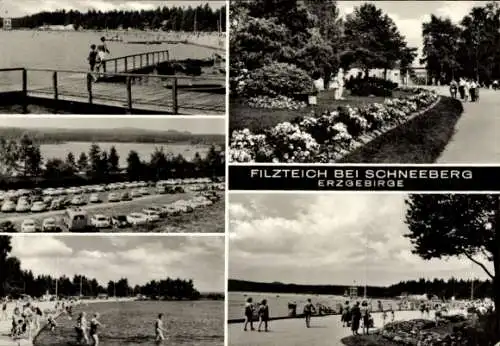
[102,50,170,73]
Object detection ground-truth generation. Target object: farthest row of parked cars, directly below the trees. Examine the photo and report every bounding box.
[0,178,223,201]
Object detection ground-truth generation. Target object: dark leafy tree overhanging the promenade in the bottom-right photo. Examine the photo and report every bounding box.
[406,194,500,335]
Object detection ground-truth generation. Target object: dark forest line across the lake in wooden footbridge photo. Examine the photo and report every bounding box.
[6,3,226,32]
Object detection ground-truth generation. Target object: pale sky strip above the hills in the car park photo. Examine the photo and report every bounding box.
[0,115,226,135]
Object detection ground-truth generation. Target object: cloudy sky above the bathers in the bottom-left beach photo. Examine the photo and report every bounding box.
[11,235,225,292]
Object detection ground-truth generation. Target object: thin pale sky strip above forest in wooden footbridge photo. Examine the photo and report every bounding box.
[0,0,225,17]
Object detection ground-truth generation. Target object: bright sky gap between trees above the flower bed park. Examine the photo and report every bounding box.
[338,1,487,66]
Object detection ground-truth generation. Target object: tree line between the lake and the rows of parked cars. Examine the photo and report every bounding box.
[0,134,225,182]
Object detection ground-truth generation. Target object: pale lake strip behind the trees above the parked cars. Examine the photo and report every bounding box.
[40,142,210,167]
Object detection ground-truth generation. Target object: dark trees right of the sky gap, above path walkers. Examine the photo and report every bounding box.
[421,1,500,84]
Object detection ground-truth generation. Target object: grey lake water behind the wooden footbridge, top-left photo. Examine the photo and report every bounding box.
[0,30,220,88]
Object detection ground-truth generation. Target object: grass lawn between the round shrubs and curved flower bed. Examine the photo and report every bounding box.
[229,90,408,133]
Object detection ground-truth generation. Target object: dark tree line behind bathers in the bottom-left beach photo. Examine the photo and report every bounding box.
[0,236,201,300]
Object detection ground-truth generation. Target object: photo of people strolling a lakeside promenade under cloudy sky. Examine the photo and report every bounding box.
[227,193,492,346]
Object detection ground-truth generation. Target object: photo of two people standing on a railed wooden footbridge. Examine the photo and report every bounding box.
[0,0,227,117]
